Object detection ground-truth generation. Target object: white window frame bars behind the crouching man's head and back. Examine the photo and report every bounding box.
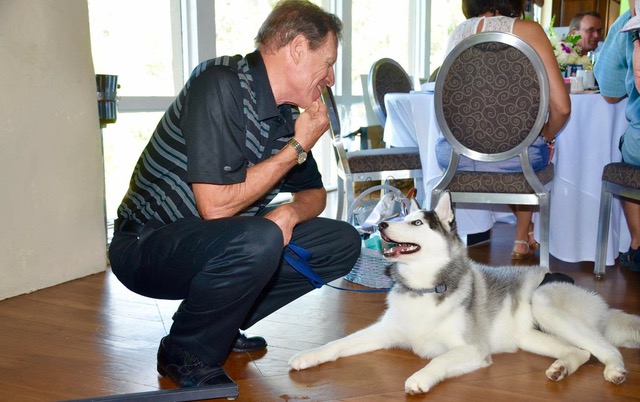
[110,0,431,190]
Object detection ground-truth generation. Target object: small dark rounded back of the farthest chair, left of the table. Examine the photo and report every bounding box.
[367,58,413,127]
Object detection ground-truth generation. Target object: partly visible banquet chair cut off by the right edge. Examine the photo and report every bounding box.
[593,162,640,279]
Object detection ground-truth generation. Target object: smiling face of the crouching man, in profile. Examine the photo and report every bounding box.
[293,34,338,108]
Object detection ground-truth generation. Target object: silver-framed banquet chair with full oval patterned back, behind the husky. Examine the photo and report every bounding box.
[431,32,554,267]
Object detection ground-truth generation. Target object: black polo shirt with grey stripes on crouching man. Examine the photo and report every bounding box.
[118,51,322,225]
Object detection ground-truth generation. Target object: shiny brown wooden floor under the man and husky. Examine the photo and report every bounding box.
[0,224,640,402]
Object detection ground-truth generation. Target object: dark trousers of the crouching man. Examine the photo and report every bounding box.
[109,217,361,365]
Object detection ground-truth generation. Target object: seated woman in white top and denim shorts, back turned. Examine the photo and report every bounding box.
[436,0,571,260]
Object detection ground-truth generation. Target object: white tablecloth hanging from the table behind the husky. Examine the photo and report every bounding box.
[384,92,631,265]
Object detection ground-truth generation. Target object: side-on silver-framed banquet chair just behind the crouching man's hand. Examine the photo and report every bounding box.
[322,87,422,221]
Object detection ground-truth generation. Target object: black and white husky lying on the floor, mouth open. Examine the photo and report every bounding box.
[289,192,640,394]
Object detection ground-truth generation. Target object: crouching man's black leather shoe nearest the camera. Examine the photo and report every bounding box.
[158,336,235,388]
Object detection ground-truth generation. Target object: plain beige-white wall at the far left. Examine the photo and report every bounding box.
[0,0,106,300]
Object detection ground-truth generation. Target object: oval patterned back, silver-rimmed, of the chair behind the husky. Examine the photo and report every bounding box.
[435,32,549,161]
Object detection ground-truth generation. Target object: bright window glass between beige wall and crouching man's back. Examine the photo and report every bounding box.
[88,0,182,222]
